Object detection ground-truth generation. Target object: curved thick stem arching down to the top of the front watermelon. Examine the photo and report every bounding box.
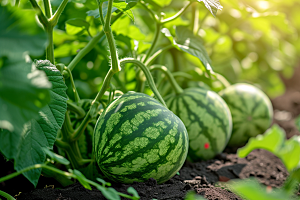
[120,58,167,108]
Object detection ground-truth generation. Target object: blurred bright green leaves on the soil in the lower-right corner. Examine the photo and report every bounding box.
[228,125,300,200]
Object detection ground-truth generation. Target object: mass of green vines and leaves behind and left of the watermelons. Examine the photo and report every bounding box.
[0,0,300,199]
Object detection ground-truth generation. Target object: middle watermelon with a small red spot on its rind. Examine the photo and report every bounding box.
[165,88,232,162]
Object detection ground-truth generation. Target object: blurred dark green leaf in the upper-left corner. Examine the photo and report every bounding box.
[0,6,47,59]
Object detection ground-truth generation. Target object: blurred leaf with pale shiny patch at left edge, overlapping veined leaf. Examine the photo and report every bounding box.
[0,59,51,134]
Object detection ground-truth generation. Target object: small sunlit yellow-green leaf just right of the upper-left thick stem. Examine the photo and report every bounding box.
[66,19,90,35]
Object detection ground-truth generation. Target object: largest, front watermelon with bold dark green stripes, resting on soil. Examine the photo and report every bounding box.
[93,92,188,184]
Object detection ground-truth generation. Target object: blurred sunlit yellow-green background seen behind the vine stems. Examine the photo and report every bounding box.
[9,0,300,98]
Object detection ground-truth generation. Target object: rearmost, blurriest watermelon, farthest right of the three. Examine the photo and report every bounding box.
[220,83,273,146]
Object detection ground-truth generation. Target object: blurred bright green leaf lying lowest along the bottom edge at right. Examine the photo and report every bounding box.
[228,179,292,200]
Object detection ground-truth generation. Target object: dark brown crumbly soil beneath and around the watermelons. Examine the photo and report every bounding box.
[0,68,300,200]
